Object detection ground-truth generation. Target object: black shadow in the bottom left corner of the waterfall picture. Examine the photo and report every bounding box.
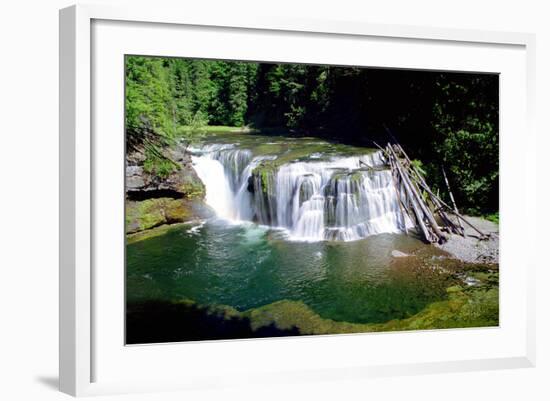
[126,301,300,344]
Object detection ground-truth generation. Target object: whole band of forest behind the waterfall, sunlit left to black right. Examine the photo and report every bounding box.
[126,56,499,215]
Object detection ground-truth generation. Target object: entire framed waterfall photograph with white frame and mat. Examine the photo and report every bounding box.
[60,6,537,395]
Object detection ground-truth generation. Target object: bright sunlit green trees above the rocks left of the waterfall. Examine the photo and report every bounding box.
[126,56,257,170]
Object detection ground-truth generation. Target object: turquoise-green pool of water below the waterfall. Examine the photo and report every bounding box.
[127,219,455,323]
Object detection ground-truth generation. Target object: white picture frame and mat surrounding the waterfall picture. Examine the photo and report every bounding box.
[59,5,537,396]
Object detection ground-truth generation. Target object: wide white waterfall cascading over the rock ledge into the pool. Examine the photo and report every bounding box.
[192,145,413,241]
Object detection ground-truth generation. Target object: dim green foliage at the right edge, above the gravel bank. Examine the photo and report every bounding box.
[432,75,499,214]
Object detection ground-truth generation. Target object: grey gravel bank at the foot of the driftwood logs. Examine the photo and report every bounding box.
[436,216,499,264]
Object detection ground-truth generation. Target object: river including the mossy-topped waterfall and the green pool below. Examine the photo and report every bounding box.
[127,134,476,323]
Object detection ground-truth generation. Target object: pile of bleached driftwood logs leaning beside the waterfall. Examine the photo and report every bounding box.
[376,143,490,243]
